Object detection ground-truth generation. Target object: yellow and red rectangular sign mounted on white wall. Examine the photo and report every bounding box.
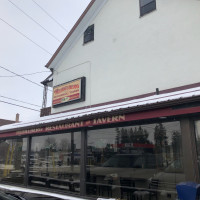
[53,77,85,107]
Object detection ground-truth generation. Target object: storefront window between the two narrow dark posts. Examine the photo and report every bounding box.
[29,132,81,192]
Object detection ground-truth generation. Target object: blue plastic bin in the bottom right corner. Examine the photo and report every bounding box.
[176,182,200,200]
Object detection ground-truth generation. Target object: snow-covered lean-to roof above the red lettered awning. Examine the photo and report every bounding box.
[0,87,200,133]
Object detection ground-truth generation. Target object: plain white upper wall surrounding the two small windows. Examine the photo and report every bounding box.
[52,0,200,112]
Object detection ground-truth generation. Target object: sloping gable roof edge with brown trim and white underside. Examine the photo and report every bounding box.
[45,0,108,69]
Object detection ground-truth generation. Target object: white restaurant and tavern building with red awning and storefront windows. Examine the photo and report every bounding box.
[0,0,200,200]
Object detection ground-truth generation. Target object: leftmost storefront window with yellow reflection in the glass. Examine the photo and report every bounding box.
[0,138,27,184]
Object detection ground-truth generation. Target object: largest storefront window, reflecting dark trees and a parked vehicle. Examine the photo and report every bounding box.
[86,122,185,200]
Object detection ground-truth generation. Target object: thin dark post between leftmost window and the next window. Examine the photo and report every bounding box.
[24,136,32,186]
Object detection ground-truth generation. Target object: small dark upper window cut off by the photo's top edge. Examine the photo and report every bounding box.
[140,0,156,17]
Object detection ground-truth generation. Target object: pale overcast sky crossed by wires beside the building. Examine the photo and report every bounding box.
[0,0,90,121]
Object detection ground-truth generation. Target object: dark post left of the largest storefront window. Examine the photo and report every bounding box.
[80,129,87,196]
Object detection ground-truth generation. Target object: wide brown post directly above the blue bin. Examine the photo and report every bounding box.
[180,118,199,182]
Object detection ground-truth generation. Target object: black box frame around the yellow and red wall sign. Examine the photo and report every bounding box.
[52,76,86,108]
